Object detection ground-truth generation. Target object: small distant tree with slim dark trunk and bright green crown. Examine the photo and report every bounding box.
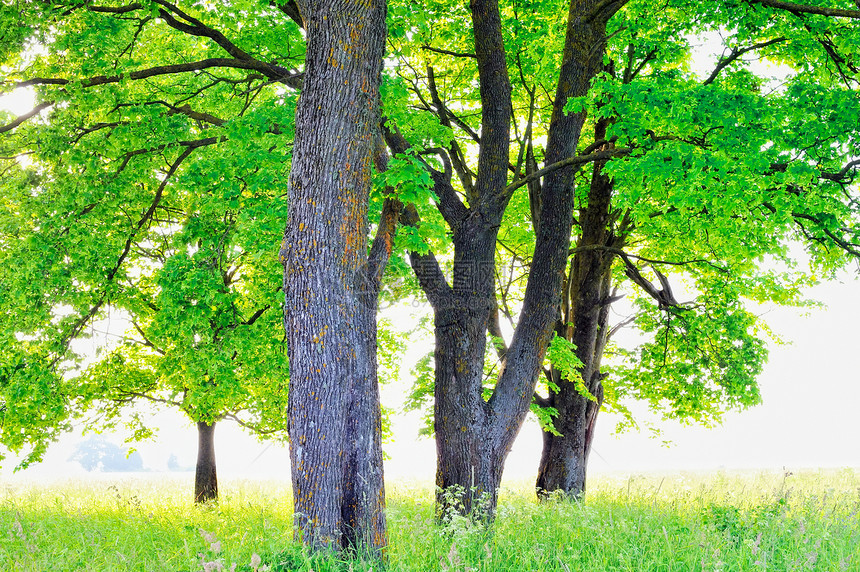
[73,182,288,502]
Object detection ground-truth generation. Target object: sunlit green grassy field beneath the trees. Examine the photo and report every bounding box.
[0,470,860,572]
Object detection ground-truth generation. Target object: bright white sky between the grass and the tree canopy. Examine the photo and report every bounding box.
[0,272,860,485]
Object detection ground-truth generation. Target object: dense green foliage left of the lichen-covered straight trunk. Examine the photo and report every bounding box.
[0,3,302,466]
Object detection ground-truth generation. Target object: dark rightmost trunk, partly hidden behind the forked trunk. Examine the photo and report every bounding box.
[535,132,624,498]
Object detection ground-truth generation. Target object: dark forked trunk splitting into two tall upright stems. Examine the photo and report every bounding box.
[420,0,617,518]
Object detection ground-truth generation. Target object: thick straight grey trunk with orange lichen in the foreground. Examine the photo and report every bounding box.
[281,0,386,552]
